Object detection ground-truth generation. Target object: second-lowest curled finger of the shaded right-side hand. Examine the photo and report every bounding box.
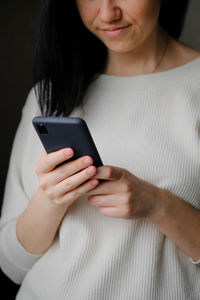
[88,194,124,206]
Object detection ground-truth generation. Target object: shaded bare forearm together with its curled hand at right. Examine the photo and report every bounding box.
[87,166,200,264]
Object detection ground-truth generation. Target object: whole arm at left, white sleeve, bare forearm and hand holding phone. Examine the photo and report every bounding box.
[0,87,98,284]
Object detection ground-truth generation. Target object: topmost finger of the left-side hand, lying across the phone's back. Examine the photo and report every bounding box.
[38,148,74,173]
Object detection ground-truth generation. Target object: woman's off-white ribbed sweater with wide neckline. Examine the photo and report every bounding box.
[0,58,200,300]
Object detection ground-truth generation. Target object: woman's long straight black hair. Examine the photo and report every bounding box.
[33,0,189,116]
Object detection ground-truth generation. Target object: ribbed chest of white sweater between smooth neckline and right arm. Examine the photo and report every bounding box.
[82,88,200,205]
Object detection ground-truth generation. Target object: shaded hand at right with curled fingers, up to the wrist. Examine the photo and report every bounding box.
[86,165,163,219]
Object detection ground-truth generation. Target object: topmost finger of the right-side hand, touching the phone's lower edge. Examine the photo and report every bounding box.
[90,165,125,181]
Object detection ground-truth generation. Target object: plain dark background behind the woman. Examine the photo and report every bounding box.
[0,0,200,300]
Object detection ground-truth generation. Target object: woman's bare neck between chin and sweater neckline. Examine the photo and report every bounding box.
[104,26,168,76]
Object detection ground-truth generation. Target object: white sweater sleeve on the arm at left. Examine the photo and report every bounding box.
[0,89,41,284]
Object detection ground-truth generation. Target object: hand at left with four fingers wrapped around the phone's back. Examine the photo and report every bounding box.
[35,148,99,207]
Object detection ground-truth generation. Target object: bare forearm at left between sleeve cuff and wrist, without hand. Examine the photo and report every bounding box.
[16,189,67,254]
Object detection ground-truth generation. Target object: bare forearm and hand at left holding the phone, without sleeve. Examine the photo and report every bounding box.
[16,149,98,254]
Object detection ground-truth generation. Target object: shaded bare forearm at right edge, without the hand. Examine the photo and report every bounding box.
[146,190,200,261]
